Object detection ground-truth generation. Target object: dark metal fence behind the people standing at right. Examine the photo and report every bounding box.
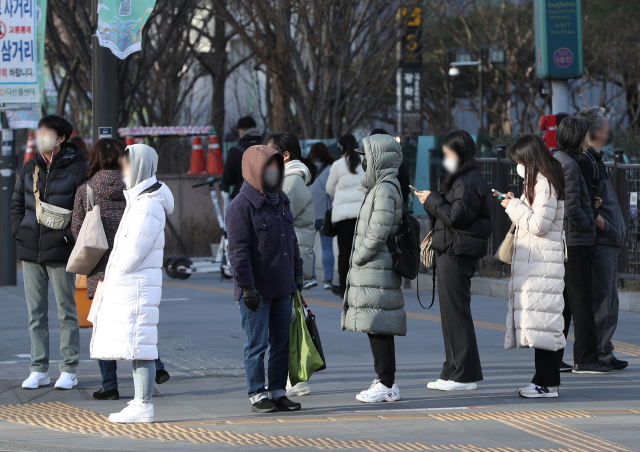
[429,146,640,279]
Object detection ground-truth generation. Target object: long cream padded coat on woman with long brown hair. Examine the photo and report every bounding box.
[504,175,566,351]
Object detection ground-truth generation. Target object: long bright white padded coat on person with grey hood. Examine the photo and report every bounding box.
[91,176,173,360]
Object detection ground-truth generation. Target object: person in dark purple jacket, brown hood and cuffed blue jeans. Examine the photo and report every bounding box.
[226,145,303,413]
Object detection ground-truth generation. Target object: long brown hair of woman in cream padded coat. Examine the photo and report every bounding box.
[509,133,564,204]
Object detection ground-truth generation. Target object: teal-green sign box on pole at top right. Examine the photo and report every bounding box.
[533,0,583,114]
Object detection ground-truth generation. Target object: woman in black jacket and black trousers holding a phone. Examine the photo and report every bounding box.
[416,130,492,391]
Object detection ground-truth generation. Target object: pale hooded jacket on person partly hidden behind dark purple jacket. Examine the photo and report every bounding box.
[282,160,316,279]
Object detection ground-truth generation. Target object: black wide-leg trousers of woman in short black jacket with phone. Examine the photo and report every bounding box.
[436,254,483,383]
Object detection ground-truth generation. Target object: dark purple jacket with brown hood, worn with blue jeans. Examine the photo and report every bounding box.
[226,145,304,301]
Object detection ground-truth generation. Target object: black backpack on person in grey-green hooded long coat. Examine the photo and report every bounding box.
[383,180,420,280]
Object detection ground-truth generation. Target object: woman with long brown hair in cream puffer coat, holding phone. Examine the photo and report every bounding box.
[494,134,566,398]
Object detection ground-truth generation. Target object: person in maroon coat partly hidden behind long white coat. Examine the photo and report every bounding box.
[71,138,169,400]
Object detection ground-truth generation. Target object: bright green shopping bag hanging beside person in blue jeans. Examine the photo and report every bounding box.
[289,292,324,386]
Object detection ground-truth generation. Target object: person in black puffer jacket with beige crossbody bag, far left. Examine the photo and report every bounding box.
[11,115,87,389]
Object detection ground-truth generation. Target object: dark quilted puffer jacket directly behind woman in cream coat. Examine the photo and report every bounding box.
[553,152,596,246]
